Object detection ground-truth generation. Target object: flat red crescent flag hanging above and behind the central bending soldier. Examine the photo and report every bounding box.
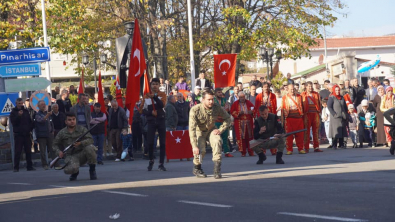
[214,54,237,88]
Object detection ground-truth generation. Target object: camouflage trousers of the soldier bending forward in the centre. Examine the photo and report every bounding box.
[193,130,223,165]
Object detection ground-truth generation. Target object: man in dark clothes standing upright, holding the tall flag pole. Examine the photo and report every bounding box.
[140,77,167,171]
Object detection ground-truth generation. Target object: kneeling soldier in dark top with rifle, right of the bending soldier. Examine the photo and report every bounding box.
[250,106,285,164]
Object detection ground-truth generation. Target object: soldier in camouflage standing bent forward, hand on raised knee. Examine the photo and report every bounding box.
[189,91,230,179]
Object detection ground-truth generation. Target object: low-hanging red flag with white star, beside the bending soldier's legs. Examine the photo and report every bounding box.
[166,130,193,160]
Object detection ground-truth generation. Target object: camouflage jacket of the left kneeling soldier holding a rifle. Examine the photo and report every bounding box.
[53,125,93,153]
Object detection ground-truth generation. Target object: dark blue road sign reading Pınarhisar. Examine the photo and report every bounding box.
[0,47,51,66]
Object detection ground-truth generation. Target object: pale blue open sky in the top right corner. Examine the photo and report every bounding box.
[326,0,395,37]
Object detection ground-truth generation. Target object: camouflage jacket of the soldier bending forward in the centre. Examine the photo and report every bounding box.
[189,103,231,147]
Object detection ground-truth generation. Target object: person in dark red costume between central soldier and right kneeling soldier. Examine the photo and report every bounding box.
[230,91,254,157]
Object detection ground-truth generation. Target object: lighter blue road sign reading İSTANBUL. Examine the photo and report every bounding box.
[0,63,41,78]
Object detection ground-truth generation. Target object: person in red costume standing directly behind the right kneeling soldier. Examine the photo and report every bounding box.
[254,82,277,155]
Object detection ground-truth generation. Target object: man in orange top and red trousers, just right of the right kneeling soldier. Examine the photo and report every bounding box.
[281,84,306,155]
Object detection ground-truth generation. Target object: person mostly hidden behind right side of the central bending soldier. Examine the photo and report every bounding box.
[214,88,233,157]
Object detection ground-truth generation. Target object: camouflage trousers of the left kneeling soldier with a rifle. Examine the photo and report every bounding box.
[64,145,97,174]
